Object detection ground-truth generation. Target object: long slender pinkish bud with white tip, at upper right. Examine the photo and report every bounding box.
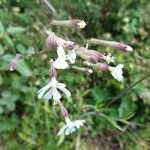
[90,38,133,51]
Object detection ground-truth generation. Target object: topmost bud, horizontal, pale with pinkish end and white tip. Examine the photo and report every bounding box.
[52,19,86,28]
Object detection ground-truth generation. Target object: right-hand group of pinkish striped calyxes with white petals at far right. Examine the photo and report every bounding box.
[77,47,124,81]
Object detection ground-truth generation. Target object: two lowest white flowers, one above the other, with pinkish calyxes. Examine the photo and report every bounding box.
[38,60,85,135]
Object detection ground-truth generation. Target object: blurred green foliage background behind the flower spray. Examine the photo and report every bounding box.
[0,0,150,150]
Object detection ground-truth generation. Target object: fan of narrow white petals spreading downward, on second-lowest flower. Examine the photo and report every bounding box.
[38,77,71,102]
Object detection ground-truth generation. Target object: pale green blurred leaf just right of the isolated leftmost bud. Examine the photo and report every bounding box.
[16,59,31,77]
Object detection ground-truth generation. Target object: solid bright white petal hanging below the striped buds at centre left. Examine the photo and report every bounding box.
[53,45,68,69]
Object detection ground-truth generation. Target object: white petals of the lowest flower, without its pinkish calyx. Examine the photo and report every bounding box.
[57,117,85,135]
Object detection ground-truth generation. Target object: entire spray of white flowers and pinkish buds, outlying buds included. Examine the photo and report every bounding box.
[10,19,133,135]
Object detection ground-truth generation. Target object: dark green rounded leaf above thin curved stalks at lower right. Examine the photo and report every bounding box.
[118,99,136,119]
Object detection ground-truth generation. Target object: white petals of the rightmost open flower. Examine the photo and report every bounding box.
[109,64,124,81]
